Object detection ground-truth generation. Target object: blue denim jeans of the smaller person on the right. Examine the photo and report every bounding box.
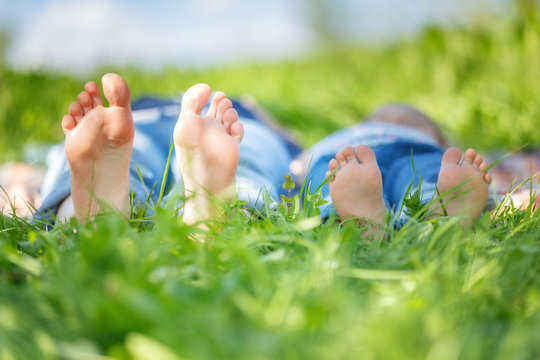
[303,121,444,222]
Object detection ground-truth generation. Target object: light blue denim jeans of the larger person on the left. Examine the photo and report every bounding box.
[35,97,296,220]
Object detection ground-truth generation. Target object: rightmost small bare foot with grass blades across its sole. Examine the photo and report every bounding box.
[434,148,491,226]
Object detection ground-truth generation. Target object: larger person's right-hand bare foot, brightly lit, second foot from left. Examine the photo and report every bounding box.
[174,84,244,224]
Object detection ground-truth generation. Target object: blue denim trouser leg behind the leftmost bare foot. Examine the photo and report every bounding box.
[40,94,180,223]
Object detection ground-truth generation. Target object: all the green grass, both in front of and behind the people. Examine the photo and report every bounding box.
[0,1,540,360]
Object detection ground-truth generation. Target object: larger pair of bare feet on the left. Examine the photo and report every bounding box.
[62,74,244,223]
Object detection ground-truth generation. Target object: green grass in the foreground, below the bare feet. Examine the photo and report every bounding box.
[0,194,540,359]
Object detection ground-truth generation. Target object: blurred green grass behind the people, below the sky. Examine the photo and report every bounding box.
[0,1,540,161]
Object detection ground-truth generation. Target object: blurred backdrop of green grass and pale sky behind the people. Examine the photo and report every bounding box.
[0,0,540,161]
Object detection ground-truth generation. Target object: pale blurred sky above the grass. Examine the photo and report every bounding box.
[0,0,510,72]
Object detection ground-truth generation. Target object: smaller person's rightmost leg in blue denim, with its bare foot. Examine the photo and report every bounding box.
[386,145,491,226]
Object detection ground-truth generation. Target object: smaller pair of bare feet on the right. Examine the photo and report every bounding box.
[326,145,491,226]
